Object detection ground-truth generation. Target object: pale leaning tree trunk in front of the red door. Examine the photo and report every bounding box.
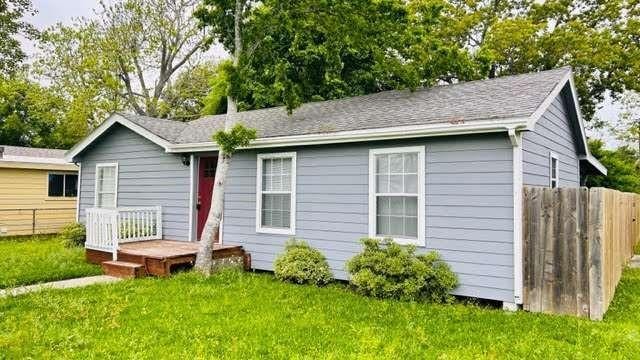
[195,0,246,275]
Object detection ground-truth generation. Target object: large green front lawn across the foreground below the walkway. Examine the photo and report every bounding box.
[0,270,640,359]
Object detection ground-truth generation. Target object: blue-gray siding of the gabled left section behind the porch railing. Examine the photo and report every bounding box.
[78,125,190,240]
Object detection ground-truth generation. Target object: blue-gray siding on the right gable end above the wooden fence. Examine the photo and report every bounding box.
[522,95,580,187]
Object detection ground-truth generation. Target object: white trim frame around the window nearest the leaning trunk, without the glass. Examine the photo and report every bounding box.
[256,152,297,235]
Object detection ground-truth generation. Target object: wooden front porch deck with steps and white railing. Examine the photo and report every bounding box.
[85,206,251,277]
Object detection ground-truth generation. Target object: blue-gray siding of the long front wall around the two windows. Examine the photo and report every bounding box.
[223,133,513,301]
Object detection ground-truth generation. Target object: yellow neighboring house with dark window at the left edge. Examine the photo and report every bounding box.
[0,145,78,236]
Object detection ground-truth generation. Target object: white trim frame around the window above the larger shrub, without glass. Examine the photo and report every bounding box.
[369,146,426,246]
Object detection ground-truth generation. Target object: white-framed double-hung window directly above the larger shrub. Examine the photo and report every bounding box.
[369,146,425,246]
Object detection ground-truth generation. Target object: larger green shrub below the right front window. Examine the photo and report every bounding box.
[347,238,458,302]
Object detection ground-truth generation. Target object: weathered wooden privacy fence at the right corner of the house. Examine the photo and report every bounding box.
[523,187,640,320]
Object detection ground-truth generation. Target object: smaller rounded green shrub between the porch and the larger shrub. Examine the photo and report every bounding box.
[275,239,333,285]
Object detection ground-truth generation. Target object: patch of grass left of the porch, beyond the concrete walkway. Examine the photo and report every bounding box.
[0,236,101,288]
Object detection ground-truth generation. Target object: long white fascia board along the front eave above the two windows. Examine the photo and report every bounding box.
[167,118,529,153]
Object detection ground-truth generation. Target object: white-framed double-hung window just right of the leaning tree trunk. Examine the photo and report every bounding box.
[256,153,296,235]
